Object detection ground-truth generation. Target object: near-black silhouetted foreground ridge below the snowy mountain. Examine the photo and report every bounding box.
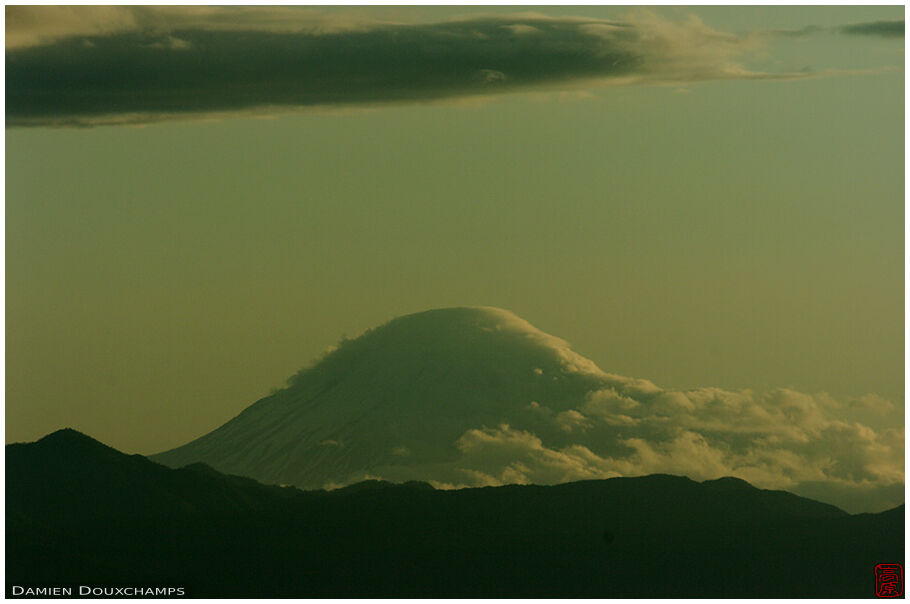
[6,430,904,598]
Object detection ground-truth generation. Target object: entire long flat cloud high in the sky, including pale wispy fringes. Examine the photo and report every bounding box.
[6,6,820,126]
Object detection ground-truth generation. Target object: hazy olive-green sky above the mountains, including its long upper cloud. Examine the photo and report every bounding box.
[6,6,904,453]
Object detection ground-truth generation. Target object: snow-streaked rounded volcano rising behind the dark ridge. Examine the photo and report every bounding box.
[151,307,640,488]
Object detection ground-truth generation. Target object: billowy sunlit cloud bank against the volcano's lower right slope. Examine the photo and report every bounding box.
[448,376,904,507]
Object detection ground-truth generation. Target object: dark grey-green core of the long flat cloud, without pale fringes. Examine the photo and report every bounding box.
[6,21,641,123]
